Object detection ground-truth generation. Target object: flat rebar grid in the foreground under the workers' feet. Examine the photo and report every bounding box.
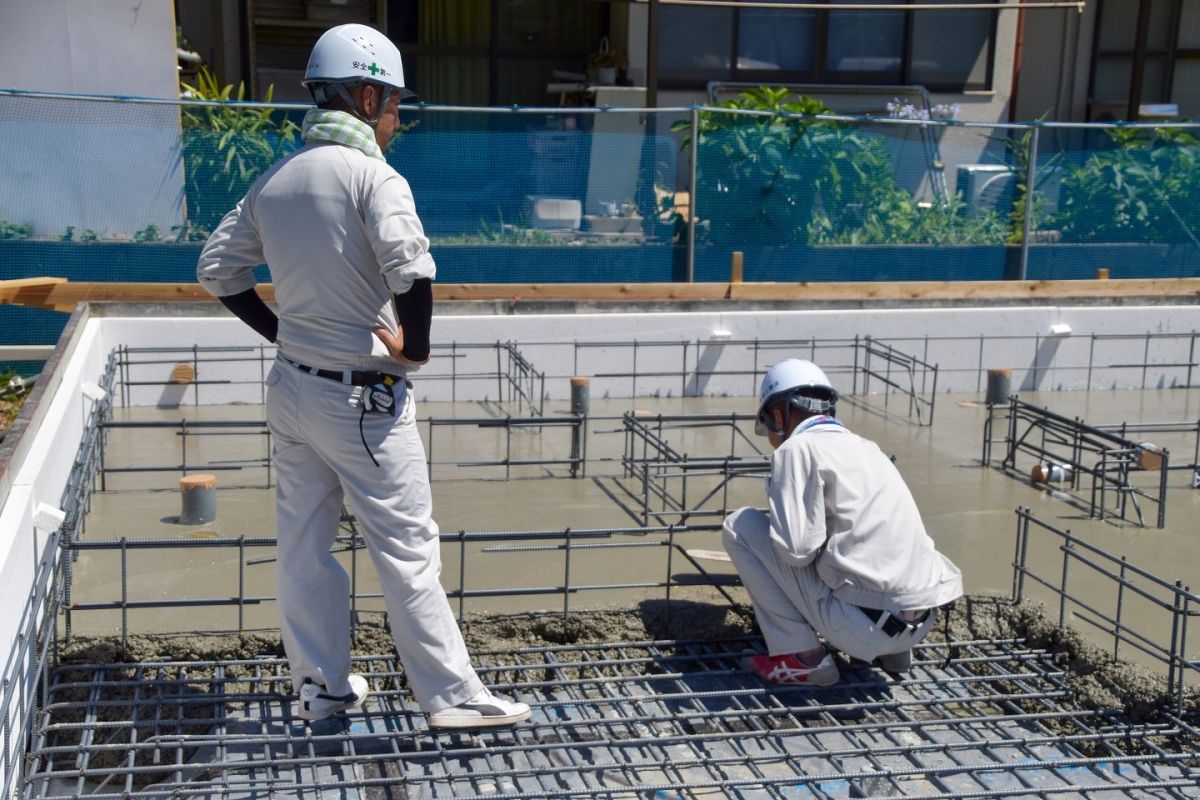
[24,639,1200,800]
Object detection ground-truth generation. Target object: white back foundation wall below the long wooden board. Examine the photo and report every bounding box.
[103,306,1200,405]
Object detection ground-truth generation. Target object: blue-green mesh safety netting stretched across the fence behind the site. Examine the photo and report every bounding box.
[0,90,1200,367]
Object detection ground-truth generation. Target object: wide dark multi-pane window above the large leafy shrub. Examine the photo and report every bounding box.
[659,0,996,91]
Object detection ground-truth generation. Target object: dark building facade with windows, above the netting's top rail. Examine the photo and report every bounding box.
[176,0,1200,121]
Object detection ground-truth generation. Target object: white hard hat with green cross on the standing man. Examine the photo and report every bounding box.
[304,24,415,100]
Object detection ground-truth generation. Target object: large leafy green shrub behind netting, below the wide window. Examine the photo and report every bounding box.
[672,86,1007,245]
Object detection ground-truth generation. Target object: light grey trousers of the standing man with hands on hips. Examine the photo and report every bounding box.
[266,361,482,714]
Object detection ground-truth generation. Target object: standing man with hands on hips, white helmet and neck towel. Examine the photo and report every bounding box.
[197,25,530,728]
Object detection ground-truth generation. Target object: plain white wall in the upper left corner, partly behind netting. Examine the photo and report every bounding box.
[0,0,184,237]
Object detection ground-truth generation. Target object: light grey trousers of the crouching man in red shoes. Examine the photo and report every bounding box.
[721,509,934,661]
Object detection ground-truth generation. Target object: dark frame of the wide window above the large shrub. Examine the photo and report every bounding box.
[658,0,1000,94]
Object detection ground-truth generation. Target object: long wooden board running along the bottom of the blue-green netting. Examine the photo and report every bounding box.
[0,278,1200,312]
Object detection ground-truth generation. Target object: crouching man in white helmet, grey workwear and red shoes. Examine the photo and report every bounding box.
[724,359,962,686]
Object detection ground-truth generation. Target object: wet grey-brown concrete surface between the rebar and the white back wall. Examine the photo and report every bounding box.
[72,390,1200,666]
